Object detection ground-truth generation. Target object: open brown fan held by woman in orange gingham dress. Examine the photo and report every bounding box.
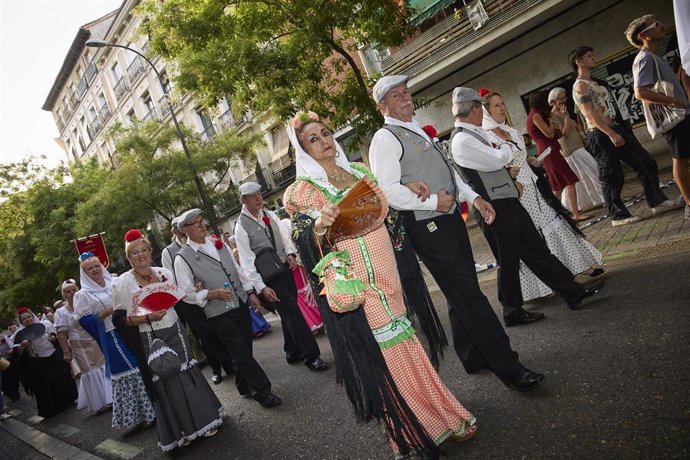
[326,176,388,243]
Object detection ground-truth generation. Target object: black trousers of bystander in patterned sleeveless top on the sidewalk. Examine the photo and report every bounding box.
[586,123,667,219]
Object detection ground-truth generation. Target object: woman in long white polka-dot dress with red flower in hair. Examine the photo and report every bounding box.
[482,92,603,301]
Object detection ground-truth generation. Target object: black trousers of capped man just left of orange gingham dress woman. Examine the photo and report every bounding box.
[267,265,321,361]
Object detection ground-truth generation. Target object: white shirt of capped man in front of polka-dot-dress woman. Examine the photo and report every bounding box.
[450,121,513,172]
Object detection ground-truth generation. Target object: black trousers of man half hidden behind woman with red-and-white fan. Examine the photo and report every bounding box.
[175,302,235,374]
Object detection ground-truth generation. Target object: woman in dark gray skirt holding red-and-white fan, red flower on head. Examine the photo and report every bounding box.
[113,230,223,452]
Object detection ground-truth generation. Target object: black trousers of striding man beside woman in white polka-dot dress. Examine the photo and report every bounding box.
[475,198,582,317]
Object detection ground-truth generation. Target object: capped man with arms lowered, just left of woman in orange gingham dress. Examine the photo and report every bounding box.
[235,182,328,372]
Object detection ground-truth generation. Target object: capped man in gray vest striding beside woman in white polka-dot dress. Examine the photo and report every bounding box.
[451,87,603,326]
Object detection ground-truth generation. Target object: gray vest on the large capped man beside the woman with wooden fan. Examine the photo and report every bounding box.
[383,124,458,220]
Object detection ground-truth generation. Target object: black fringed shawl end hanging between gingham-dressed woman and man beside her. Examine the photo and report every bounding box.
[386,208,448,370]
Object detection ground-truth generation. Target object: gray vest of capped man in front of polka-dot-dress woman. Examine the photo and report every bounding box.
[450,128,520,201]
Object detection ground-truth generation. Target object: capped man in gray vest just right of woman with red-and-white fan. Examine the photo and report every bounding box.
[174,209,281,407]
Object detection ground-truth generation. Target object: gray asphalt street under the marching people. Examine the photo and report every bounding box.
[0,174,690,459]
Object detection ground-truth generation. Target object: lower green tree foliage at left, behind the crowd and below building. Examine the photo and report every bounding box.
[0,121,260,321]
